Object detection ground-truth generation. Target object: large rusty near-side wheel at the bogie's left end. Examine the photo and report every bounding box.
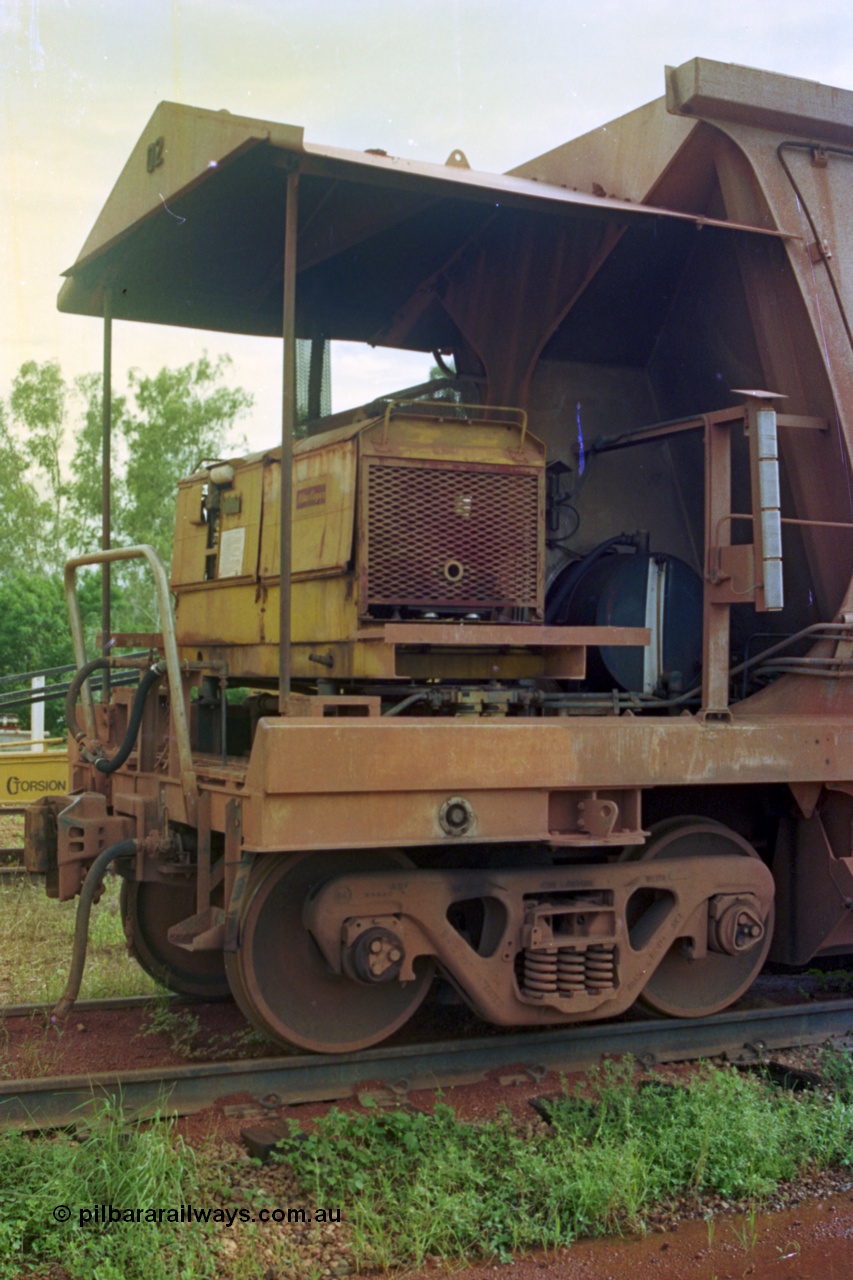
[225,850,434,1053]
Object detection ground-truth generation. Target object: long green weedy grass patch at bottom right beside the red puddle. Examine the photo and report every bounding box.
[272,1049,853,1267]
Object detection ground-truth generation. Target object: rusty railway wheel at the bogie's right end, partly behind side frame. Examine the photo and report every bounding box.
[625,818,774,1018]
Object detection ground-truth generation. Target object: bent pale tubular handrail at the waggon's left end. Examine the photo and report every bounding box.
[65,545,197,806]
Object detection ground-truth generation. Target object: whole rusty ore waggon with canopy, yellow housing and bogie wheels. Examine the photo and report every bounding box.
[28,59,853,1051]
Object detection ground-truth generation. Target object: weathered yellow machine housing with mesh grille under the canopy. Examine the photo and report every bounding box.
[172,403,546,681]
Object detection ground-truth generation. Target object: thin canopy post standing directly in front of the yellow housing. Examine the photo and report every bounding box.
[278,160,300,716]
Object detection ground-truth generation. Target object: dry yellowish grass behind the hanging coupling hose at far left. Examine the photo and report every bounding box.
[0,876,163,1005]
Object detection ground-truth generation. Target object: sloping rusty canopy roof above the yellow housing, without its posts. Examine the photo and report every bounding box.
[59,102,779,351]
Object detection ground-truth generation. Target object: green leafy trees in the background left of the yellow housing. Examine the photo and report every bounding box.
[0,356,251,701]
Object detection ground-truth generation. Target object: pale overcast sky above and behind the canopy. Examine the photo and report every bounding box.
[0,0,853,447]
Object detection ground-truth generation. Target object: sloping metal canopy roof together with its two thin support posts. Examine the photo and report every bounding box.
[59,90,804,714]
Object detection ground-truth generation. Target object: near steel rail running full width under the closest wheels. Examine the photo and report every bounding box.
[0,1000,853,1130]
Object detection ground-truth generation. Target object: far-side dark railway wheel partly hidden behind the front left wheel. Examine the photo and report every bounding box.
[120,881,231,1000]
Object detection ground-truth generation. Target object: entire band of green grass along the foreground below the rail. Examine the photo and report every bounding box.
[0,1051,853,1280]
